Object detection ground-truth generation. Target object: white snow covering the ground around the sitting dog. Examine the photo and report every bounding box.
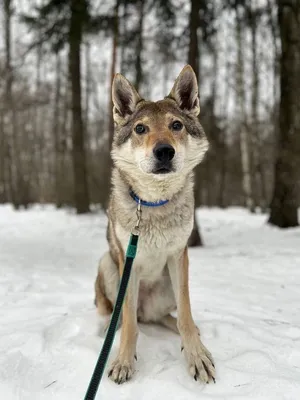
[0,206,300,400]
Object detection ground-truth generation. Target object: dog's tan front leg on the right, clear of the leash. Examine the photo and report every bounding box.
[168,248,215,383]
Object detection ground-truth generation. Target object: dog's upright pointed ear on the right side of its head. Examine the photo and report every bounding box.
[168,65,200,116]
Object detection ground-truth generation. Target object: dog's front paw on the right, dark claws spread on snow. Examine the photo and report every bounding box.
[183,336,216,383]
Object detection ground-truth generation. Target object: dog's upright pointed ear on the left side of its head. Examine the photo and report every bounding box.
[112,74,141,123]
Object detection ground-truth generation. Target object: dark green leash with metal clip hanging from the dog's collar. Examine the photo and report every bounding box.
[84,202,142,400]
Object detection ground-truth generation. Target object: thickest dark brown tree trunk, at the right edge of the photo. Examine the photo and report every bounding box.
[269,0,300,228]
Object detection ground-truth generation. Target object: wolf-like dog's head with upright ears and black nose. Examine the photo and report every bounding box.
[112,65,208,179]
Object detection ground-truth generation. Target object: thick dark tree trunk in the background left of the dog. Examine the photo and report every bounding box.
[69,0,90,214]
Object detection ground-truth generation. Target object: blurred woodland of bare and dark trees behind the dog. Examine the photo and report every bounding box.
[0,0,300,244]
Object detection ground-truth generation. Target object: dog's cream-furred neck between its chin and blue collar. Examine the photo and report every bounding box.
[113,167,192,202]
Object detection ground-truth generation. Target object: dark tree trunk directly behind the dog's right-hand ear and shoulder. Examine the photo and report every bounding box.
[188,0,202,247]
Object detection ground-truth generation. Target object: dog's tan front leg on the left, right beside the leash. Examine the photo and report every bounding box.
[108,253,139,384]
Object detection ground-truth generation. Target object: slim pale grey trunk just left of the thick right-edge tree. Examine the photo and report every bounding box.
[236,7,254,211]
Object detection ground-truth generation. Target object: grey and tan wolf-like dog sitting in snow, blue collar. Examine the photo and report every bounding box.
[95,65,215,384]
